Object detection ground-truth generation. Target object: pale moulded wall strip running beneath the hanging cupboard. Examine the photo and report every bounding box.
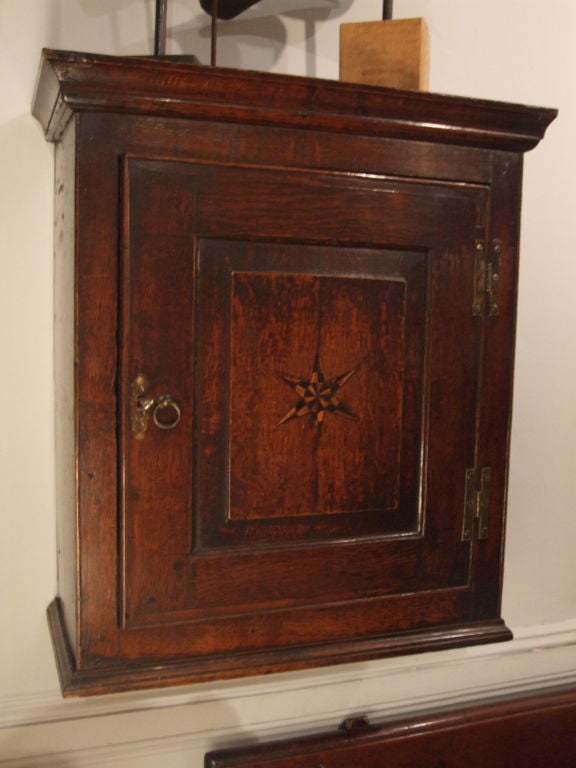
[0,621,576,768]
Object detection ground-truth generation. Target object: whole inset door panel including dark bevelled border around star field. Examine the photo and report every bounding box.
[197,240,427,549]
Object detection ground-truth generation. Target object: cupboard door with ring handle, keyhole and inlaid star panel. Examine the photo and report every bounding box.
[118,158,504,669]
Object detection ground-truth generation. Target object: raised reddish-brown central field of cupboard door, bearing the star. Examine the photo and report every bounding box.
[228,270,405,521]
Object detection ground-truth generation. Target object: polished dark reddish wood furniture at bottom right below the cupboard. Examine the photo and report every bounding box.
[205,688,576,768]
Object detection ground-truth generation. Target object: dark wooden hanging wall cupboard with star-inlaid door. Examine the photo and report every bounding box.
[34,51,555,695]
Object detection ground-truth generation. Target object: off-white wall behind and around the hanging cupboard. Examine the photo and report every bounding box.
[0,0,576,768]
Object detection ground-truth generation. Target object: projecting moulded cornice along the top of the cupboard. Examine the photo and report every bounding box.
[33,50,557,152]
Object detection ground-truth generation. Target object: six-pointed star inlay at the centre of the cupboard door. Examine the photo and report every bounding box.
[278,353,360,426]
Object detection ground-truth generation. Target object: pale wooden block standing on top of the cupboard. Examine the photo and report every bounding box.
[340,19,430,91]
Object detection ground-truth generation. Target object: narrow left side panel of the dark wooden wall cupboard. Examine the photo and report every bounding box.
[54,122,77,660]
